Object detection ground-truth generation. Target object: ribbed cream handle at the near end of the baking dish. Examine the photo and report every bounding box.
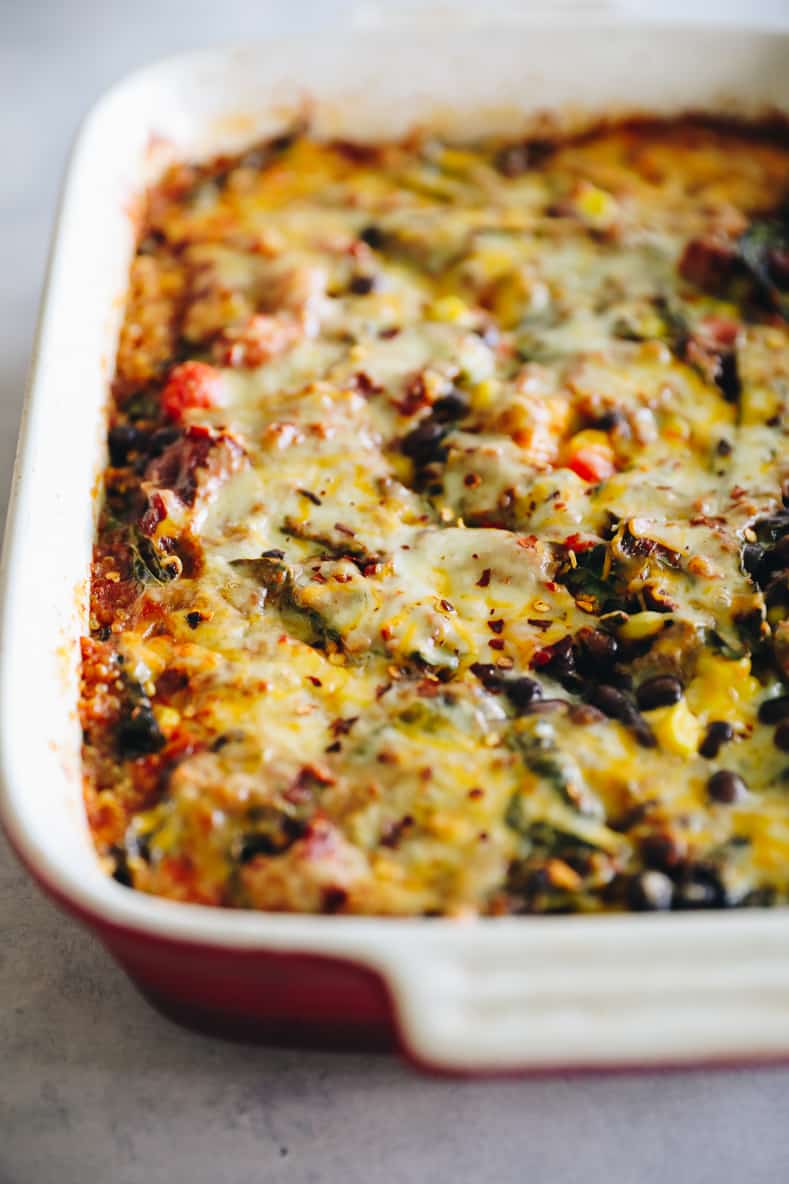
[383,916,789,1073]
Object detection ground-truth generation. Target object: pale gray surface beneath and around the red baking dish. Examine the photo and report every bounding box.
[0,0,789,1184]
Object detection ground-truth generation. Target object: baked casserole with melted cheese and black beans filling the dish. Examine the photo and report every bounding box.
[81,120,789,914]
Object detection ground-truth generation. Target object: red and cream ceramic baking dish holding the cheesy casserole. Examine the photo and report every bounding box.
[0,22,789,1070]
